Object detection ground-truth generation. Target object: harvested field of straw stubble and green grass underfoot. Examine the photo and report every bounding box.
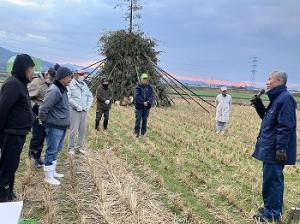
[17,101,300,224]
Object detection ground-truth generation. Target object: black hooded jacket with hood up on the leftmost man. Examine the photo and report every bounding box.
[0,54,34,135]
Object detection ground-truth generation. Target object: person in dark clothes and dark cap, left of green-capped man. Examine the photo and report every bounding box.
[95,78,112,131]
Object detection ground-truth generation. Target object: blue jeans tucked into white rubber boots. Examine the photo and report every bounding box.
[45,127,67,166]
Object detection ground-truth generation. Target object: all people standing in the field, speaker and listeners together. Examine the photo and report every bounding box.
[0,54,297,222]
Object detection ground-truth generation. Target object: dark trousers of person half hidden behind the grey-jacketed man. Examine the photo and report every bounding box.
[29,119,46,159]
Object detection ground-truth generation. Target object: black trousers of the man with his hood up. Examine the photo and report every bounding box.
[0,133,26,202]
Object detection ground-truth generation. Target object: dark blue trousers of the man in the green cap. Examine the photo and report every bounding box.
[134,108,150,135]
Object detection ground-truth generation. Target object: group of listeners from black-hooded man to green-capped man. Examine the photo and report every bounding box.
[0,54,155,202]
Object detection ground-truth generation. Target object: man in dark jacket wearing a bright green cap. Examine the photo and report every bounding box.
[134,73,154,138]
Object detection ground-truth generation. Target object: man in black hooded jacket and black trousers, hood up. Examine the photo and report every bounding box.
[0,54,34,202]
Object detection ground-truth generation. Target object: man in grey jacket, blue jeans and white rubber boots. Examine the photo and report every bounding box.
[39,67,72,185]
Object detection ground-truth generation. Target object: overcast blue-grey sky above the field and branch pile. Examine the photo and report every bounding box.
[0,0,300,84]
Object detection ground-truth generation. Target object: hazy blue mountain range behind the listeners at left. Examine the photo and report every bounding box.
[0,47,90,72]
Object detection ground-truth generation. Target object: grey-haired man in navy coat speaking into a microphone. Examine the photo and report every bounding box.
[251,71,297,222]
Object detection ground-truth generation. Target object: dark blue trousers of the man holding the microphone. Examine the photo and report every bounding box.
[262,163,284,219]
